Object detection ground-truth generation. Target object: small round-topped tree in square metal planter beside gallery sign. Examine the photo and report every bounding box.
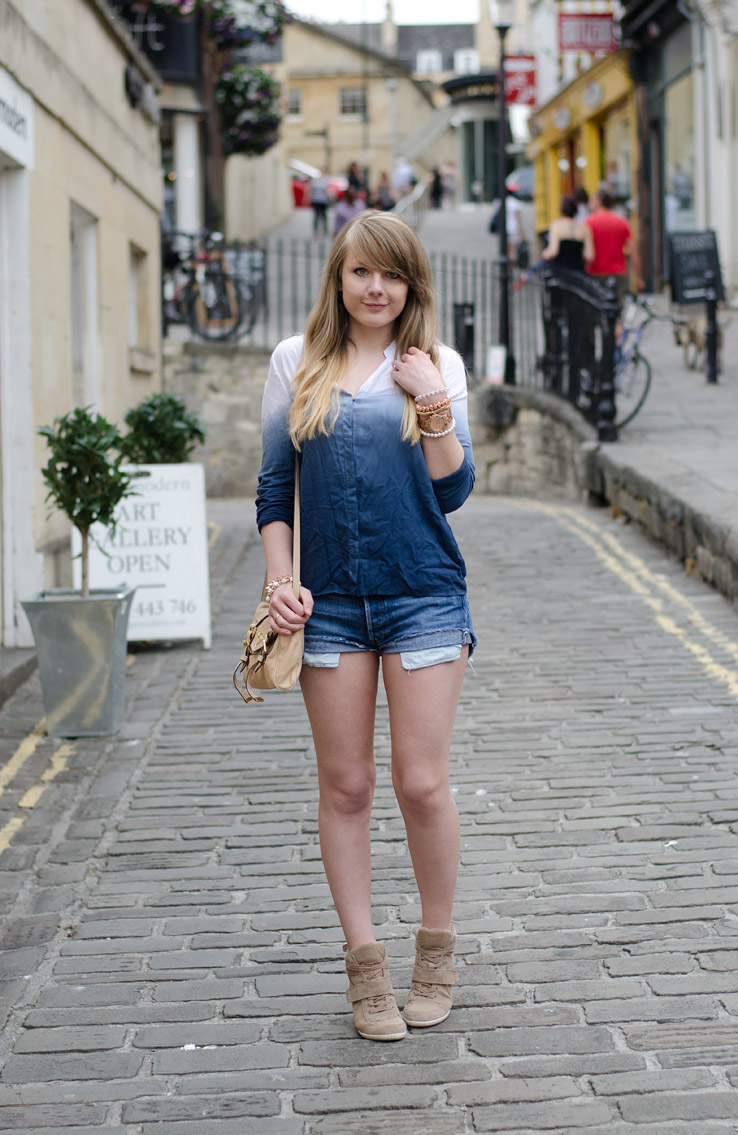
[23,407,136,737]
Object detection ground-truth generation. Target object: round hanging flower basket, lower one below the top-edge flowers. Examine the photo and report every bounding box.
[215,64,279,155]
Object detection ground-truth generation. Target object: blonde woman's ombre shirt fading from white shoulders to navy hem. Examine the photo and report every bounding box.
[257,335,475,596]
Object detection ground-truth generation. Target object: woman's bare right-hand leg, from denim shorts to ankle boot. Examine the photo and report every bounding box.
[381,646,469,930]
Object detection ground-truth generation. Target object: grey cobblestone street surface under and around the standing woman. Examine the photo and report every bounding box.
[0,497,738,1135]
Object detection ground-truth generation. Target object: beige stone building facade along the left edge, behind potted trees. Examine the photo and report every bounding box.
[0,0,161,646]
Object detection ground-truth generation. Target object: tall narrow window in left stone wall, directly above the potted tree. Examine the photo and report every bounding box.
[69,202,99,406]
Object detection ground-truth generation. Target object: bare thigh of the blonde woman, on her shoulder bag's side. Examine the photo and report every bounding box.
[300,650,379,781]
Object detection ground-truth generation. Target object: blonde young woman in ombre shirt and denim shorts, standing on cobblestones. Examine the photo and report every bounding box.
[257,210,476,1041]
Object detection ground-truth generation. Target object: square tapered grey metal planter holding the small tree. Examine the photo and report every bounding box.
[23,588,135,737]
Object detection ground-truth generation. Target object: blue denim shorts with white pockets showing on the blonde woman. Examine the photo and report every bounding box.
[303,595,477,670]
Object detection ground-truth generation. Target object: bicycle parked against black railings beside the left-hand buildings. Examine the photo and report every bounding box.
[161,233,249,342]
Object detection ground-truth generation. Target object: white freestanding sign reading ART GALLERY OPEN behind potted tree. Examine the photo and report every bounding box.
[73,464,211,648]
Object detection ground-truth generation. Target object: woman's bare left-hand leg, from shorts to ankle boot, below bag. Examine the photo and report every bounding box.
[300,651,379,950]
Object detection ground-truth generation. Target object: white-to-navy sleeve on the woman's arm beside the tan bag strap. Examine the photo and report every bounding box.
[257,336,302,531]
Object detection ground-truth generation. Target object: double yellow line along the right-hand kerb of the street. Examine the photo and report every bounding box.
[505,498,738,700]
